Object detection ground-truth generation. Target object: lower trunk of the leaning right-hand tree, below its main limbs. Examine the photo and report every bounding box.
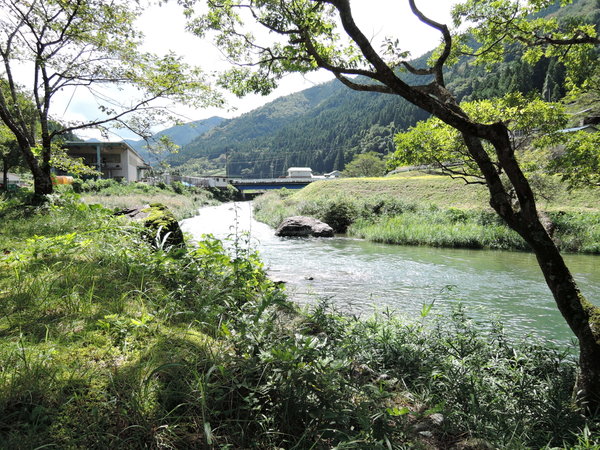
[463,126,600,414]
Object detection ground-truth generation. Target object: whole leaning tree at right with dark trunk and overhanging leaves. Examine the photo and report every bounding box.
[191,0,600,411]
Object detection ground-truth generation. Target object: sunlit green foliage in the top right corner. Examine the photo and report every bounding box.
[452,0,600,93]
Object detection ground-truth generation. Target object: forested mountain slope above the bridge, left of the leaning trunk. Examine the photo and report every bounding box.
[170,59,434,177]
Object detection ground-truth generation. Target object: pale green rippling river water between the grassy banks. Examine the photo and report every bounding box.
[181,202,600,345]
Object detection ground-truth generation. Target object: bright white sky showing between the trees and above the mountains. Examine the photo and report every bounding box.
[54,0,454,140]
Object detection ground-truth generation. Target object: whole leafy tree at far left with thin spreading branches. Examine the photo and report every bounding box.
[0,0,218,197]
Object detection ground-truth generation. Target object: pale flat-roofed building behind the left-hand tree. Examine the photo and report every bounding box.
[64,142,150,182]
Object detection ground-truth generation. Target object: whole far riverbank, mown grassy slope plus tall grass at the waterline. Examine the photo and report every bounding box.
[255,173,600,253]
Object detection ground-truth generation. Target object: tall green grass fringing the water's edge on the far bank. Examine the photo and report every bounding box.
[255,183,600,253]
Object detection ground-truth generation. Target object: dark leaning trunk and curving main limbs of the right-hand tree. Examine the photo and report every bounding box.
[318,0,600,413]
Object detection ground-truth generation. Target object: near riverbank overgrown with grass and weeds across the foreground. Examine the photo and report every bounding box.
[0,192,600,449]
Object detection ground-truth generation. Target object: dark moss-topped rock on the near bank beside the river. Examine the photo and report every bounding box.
[142,203,185,249]
